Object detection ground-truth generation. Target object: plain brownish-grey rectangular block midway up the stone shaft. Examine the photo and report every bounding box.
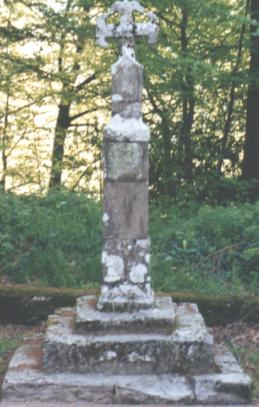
[103,182,148,240]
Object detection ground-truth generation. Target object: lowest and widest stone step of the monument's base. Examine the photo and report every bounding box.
[3,339,251,406]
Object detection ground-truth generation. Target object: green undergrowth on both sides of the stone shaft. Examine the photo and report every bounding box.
[0,191,259,296]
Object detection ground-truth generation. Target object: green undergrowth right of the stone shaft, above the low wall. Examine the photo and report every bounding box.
[151,197,259,294]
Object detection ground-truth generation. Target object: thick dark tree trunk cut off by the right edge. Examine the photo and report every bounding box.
[242,0,259,180]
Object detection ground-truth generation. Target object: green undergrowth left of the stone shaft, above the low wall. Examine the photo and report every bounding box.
[0,191,101,287]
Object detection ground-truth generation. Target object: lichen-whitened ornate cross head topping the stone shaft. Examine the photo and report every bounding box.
[97,0,159,56]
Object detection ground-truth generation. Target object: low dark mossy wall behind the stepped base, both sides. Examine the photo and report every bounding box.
[0,285,259,326]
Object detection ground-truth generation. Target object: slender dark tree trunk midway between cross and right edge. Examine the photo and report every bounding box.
[181,8,195,181]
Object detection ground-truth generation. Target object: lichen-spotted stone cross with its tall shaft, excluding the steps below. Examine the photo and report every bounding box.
[97,0,159,311]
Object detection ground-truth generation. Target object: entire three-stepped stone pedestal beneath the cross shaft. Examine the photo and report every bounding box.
[2,296,251,405]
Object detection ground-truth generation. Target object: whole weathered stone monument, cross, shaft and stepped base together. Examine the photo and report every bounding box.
[3,0,254,405]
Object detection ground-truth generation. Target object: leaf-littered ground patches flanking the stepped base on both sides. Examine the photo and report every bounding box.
[0,323,259,405]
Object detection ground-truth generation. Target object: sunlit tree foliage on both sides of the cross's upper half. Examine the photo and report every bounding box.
[0,0,258,197]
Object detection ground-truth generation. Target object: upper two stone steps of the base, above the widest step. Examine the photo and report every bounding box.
[43,297,214,375]
